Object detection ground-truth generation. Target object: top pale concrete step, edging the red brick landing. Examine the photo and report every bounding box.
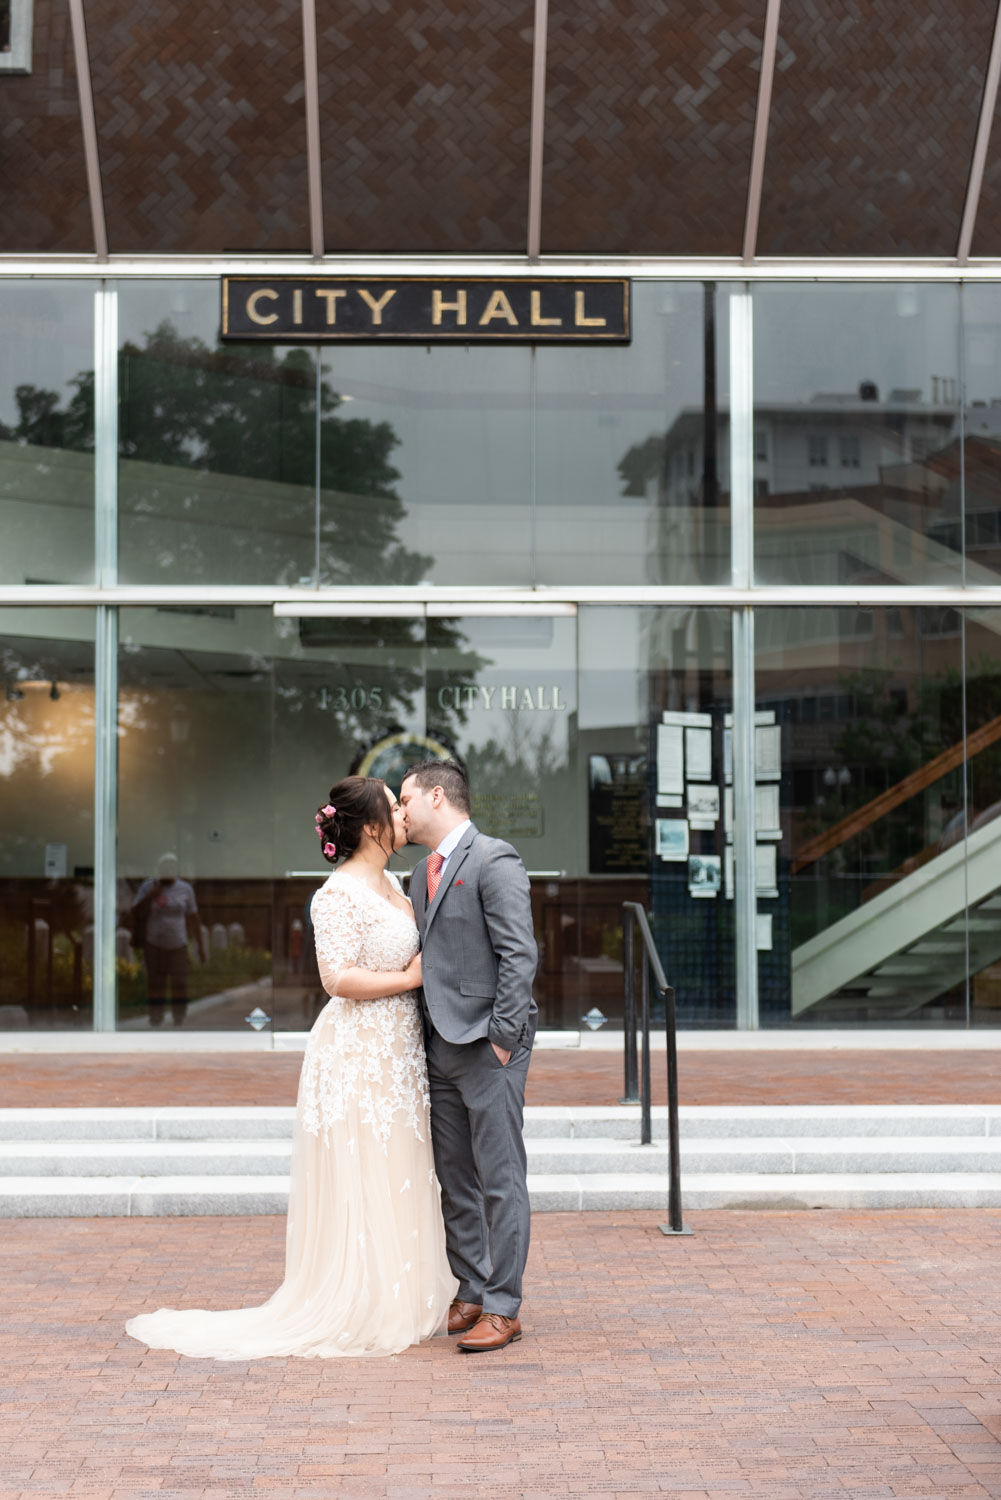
[0,1104,1001,1143]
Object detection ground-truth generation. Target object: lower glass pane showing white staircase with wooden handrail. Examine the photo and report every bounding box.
[755,606,960,1026]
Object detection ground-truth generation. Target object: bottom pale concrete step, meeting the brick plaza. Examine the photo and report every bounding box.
[0,1173,1001,1218]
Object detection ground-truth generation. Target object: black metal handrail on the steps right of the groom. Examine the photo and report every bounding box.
[623,902,690,1235]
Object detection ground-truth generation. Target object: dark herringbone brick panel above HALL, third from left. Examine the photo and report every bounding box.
[317,0,534,252]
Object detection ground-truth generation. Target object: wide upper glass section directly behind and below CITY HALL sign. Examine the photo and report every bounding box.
[119,279,729,588]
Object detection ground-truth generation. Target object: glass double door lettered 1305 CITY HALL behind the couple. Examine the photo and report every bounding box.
[272,606,582,1031]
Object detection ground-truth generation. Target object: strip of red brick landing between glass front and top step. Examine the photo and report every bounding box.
[0,1050,1001,1107]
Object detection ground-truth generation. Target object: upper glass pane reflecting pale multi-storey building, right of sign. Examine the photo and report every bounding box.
[753,284,963,585]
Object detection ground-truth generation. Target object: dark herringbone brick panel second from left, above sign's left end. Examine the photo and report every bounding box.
[86,0,309,254]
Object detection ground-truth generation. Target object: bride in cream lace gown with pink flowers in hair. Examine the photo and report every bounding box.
[126,776,458,1359]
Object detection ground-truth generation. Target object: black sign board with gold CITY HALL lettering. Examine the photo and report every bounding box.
[222,275,629,344]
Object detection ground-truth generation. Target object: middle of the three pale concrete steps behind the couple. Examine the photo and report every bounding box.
[9,1136,1001,1191]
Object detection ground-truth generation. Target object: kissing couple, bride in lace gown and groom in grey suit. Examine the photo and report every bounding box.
[126,761,537,1359]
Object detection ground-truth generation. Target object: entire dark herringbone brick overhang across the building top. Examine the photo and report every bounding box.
[0,0,1001,257]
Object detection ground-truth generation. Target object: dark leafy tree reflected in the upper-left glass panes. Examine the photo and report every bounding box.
[0,321,432,584]
